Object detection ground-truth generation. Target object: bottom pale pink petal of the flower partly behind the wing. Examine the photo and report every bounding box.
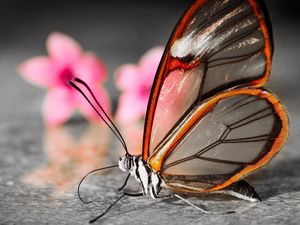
[116,93,147,123]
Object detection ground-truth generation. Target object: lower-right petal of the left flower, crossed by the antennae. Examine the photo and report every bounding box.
[76,85,110,122]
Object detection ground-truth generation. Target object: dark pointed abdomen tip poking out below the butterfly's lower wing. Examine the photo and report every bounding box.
[219,180,261,202]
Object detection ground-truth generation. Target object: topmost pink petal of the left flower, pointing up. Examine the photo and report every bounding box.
[47,32,81,66]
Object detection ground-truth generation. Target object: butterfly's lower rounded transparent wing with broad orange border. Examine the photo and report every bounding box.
[150,88,288,190]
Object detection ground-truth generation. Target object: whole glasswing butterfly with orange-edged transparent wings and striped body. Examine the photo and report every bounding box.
[71,0,289,220]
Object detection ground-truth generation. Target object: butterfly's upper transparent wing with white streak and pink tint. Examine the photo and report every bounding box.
[143,0,272,160]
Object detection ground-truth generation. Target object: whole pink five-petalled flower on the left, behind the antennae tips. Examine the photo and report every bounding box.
[19,33,110,125]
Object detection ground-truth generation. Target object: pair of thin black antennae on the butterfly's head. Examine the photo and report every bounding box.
[69,78,129,155]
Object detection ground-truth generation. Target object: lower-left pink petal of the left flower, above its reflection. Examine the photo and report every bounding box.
[44,88,75,126]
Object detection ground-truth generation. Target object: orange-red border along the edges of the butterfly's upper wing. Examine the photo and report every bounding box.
[142,0,273,161]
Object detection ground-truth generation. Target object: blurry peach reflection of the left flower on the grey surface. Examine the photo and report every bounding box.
[22,124,110,192]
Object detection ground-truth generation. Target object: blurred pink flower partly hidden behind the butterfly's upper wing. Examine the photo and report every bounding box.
[116,47,163,123]
